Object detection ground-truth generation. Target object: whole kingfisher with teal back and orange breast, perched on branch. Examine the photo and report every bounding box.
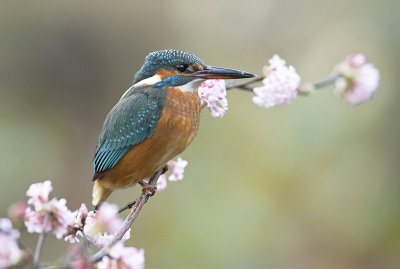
[92,49,254,205]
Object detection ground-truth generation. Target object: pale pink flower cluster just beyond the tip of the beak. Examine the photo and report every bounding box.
[253,55,300,108]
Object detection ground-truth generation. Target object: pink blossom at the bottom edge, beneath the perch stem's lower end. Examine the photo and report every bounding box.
[97,242,145,269]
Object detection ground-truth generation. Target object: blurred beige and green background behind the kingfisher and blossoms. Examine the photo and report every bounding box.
[0,0,400,269]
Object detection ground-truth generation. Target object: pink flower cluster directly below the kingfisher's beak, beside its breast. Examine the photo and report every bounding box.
[198,79,228,118]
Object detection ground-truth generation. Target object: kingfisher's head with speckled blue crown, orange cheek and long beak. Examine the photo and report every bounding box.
[133,49,254,92]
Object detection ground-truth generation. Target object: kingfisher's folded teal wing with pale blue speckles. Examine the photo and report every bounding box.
[93,87,165,173]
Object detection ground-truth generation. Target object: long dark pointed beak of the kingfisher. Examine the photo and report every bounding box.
[191,66,254,79]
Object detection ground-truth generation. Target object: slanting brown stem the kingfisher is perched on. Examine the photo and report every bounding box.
[89,168,164,263]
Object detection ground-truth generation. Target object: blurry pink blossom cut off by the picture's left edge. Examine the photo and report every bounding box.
[0,218,24,268]
